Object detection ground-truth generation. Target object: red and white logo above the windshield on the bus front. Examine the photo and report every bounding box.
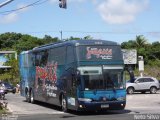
[86,47,112,59]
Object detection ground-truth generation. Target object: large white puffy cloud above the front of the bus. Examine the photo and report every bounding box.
[97,0,149,24]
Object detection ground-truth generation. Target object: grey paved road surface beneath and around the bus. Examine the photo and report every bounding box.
[1,92,160,120]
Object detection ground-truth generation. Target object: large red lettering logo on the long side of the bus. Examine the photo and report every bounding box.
[35,62,57,90]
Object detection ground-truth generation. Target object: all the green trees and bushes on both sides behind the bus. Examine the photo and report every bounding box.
[0,33,160,85]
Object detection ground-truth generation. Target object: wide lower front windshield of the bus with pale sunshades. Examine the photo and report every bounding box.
[78,66,125,90]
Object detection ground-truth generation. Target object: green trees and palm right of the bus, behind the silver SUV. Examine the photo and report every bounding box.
[121,35,160,80]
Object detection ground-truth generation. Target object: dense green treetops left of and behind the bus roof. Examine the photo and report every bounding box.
[0,33,59,53]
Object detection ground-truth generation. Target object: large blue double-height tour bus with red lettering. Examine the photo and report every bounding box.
[19,40,126,111]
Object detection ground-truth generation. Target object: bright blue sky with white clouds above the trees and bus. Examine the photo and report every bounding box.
[0,0,160,43]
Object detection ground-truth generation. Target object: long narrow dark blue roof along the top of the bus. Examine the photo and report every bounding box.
[33,40,118,51]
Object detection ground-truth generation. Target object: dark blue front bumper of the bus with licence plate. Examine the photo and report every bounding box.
[78,101,126,111]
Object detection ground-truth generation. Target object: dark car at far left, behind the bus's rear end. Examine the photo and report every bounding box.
[3,82,16,94]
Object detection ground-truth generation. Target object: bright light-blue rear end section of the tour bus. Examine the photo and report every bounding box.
[19,51,35,102]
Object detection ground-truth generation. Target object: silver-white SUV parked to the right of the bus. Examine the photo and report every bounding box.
[126,77,160,94]
